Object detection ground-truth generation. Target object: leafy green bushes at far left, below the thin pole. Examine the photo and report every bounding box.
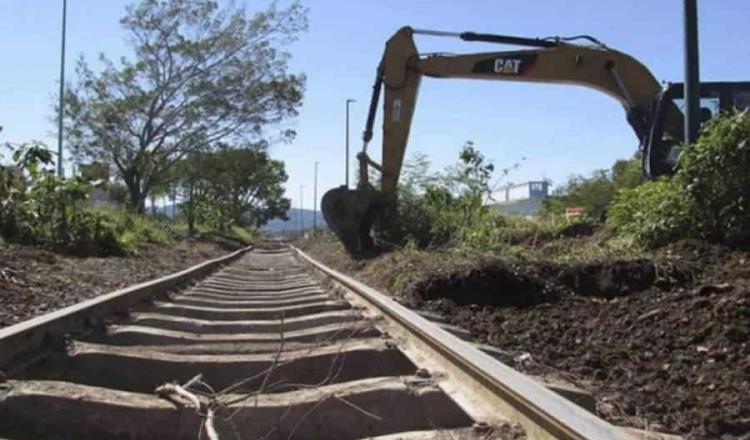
[0,142,168,256]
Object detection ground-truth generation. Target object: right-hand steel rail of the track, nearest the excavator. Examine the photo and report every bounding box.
[292,246,637,440]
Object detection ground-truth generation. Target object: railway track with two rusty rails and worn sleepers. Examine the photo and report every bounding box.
[0,244,668,440]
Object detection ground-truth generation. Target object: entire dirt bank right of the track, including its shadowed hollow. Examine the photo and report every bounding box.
[303,239,750,440]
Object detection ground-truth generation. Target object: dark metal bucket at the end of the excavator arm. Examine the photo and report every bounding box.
[321,186,380,255]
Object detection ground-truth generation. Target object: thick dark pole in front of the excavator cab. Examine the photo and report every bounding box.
[685,0,700,144]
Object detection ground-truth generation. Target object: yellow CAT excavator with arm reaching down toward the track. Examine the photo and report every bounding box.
[321,27,750,255]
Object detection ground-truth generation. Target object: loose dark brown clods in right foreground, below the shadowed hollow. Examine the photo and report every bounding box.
[468,285,750,438]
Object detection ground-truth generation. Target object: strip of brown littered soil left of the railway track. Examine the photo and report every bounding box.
[0,241,238,328]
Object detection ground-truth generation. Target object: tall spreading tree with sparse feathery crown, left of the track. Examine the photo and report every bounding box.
[65,0,307,212]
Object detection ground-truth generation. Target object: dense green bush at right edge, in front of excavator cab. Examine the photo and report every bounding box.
[611,112,750,246]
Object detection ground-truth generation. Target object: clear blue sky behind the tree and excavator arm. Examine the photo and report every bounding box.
[0,0,750,208]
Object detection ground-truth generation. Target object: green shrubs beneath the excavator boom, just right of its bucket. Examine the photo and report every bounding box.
[376,143,564,252]
